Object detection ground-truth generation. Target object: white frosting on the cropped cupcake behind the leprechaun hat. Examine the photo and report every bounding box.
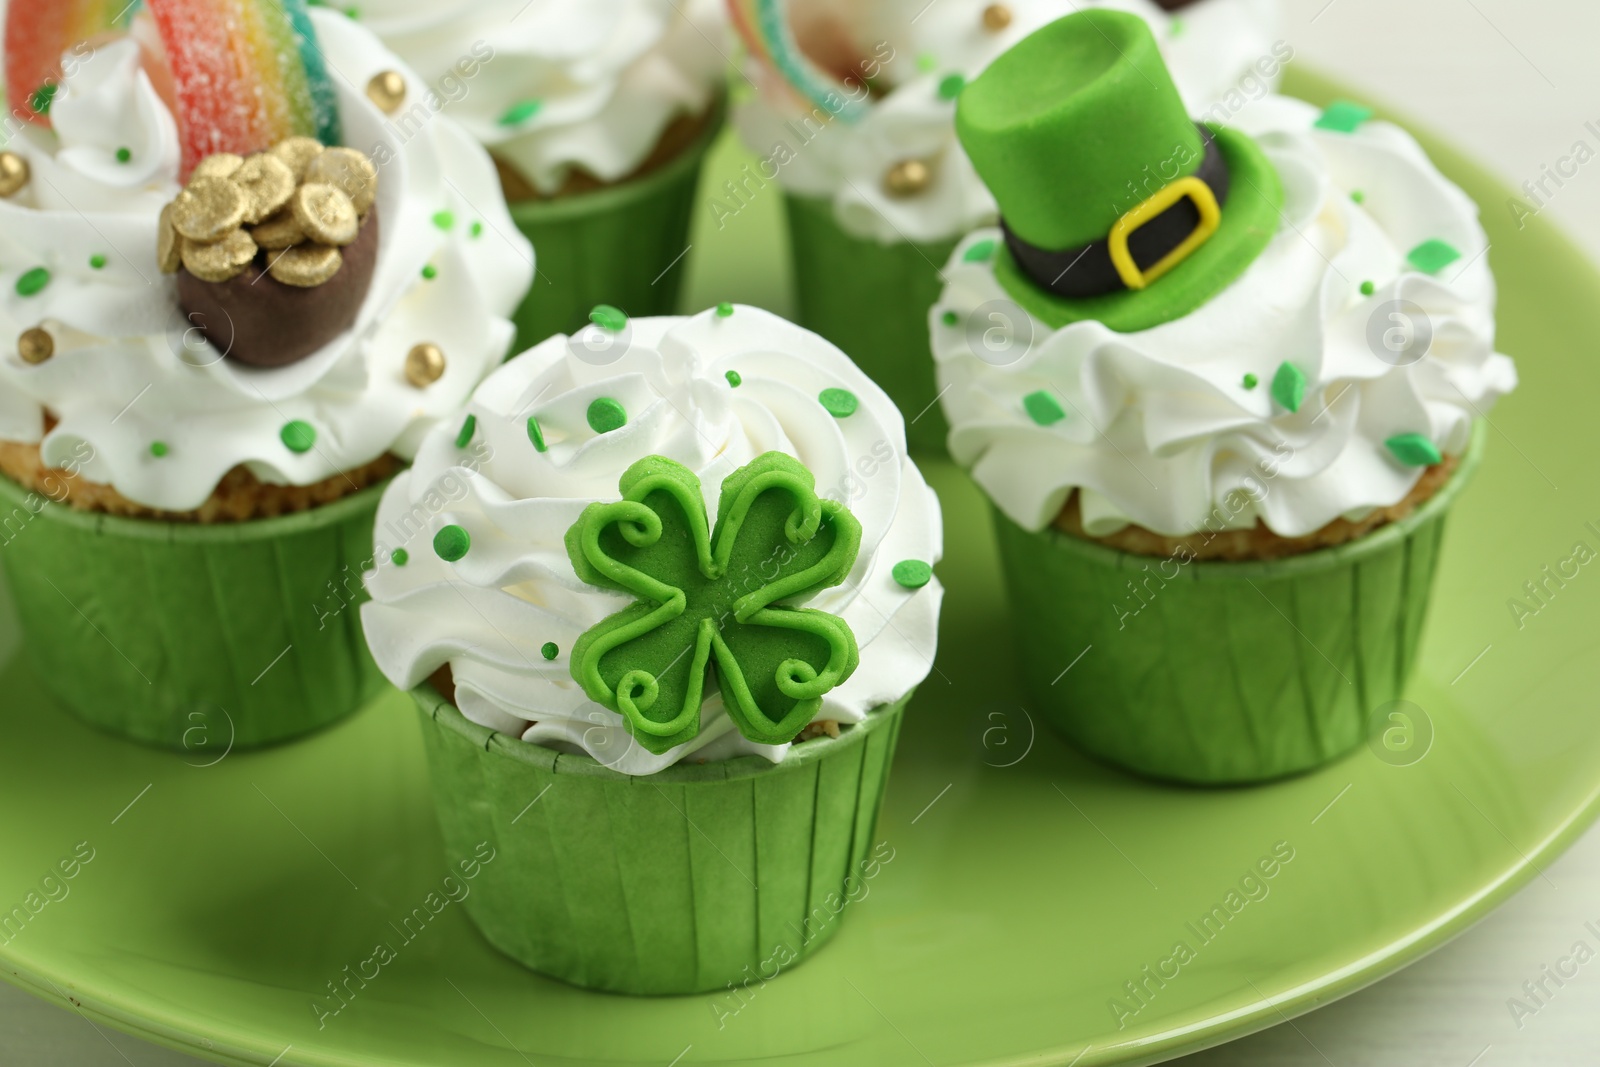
[734,0,1293,245]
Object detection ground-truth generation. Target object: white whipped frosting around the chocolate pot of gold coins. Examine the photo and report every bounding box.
[0,11,533,510]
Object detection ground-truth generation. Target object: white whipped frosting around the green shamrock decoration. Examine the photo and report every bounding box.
[362,306,942,774]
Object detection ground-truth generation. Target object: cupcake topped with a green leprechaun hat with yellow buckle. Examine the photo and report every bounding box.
[930,11,1517,782]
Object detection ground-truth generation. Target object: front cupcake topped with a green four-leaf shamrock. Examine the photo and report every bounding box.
[362,304,942,993]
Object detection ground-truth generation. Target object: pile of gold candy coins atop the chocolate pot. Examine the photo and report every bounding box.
[157,138,378,288]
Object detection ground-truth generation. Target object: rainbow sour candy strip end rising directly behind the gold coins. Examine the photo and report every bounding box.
[147,0,339,178]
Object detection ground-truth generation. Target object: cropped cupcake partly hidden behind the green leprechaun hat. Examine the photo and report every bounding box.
[732,0,1293,453]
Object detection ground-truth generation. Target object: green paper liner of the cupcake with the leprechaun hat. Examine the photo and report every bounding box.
[995,427,1483,784]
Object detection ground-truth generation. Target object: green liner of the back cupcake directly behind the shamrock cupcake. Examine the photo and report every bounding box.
[510,99,725,352]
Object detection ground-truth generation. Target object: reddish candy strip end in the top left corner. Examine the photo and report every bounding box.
[5,0,139,126]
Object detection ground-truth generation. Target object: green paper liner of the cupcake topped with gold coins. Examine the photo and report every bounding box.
[0,478,384,757]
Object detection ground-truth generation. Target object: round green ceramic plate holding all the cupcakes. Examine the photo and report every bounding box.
[0,70,1600,1067]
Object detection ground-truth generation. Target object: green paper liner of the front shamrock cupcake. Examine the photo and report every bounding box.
[411,686,910,993]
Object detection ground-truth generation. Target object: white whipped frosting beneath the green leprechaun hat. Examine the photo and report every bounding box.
[930,98,1517,537]
